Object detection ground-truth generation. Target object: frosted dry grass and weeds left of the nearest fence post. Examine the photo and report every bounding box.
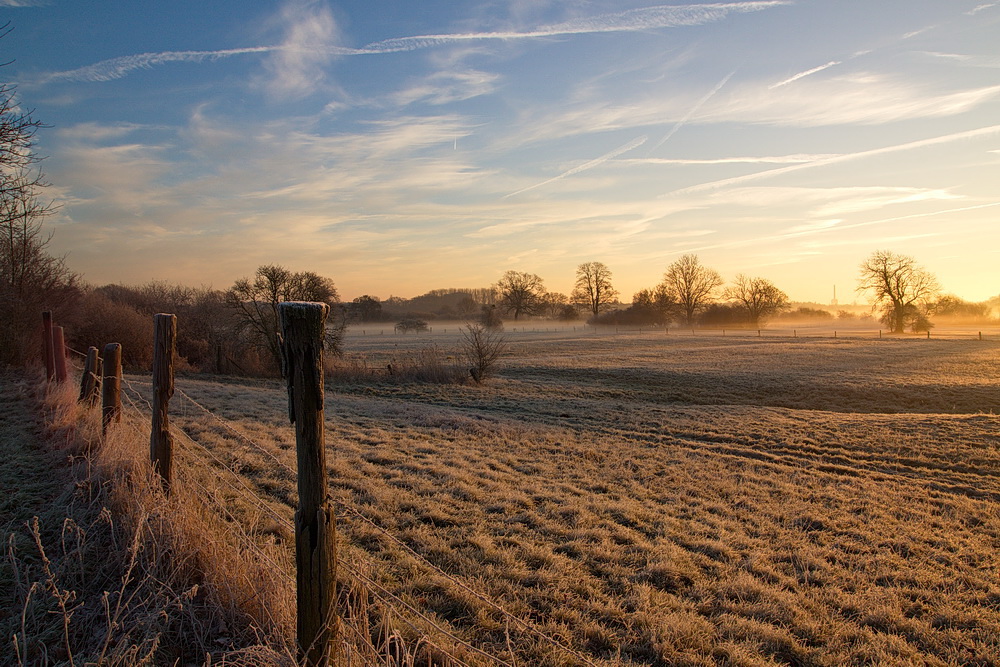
[0,376,294,665]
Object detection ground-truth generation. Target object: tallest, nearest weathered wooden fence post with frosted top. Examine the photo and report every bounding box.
[278,301,337,667]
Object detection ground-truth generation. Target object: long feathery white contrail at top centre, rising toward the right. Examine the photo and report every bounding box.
[361,0,791,53]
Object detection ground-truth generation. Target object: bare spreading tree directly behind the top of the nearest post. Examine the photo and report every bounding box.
[226,264,345,367]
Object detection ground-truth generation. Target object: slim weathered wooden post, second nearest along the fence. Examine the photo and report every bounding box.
[149,313,177,493]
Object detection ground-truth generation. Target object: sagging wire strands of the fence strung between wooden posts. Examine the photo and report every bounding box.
[114,370,597,667]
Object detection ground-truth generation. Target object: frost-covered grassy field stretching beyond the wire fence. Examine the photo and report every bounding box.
[150,328,1000,665]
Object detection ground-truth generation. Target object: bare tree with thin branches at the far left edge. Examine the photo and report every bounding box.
[0,39,80,365]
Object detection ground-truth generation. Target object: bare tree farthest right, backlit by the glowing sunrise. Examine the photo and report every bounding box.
[858,250,941,333]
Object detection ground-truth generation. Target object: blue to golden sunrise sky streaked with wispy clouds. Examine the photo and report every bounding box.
[0,0,1000,304]
